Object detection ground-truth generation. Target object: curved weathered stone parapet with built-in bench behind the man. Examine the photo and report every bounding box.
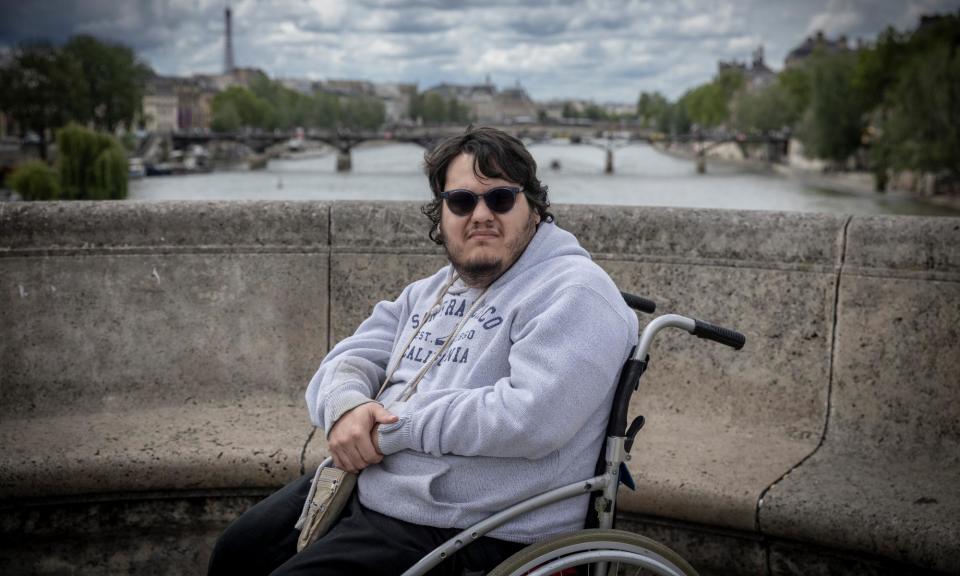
[0,202,960,574]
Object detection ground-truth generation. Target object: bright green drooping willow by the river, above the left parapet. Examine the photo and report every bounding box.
[57,124,127,200]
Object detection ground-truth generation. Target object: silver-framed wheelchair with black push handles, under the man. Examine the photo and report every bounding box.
[394,293,746,576]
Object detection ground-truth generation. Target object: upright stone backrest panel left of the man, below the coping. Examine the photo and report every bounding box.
[0,253,328,417]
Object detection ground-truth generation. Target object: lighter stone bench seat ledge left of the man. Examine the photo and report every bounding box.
[0,396,312,501]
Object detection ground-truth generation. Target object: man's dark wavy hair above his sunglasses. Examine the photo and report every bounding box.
[420,127,554,244]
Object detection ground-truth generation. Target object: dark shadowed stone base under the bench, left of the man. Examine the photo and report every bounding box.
[0,493,266,576]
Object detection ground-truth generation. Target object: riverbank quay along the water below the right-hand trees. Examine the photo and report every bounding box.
[654,143,960,212]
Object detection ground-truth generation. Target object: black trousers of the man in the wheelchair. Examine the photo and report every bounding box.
[207,474,524,576]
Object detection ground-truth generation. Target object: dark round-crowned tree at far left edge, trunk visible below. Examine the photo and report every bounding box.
[0,44,88,159]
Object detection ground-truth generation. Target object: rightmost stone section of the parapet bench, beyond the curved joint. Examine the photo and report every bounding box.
[760,218,960,571]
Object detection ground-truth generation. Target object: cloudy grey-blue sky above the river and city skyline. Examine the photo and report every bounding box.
[0,0,960,102]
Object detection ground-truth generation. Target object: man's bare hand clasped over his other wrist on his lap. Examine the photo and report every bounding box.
[327,402,397,473]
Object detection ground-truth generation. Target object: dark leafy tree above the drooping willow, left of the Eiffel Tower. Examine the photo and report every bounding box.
[63,34,151,132]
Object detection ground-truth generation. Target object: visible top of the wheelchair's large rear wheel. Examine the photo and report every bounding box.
[489,529,697,576]
